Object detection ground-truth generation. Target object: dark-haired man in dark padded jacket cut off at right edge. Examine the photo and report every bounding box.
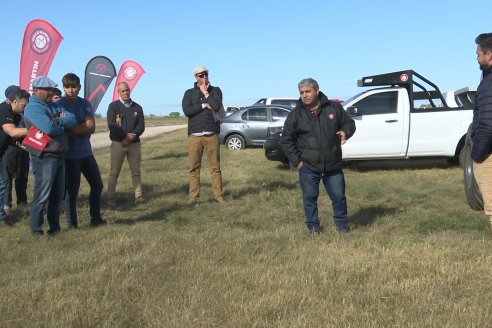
[471,33,492,225]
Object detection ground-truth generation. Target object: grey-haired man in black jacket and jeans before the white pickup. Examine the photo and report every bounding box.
[281,78,355,234]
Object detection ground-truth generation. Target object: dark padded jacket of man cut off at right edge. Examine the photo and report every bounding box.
[471,66,492,163]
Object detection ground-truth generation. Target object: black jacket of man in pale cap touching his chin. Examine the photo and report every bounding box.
[182,82,222,135]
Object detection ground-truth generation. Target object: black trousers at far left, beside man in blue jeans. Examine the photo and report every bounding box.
[3,145,29,208]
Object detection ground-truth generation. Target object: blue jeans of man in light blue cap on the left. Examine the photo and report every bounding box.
[29,156,65,235]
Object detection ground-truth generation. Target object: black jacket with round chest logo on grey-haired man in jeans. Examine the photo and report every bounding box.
[281,92,355,172]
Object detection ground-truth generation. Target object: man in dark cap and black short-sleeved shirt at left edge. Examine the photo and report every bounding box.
[0,85,29,225]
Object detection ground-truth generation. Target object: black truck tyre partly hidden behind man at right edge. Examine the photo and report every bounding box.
[460,125,483,211]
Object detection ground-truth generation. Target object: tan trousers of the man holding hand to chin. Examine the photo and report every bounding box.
[188,134,223,199]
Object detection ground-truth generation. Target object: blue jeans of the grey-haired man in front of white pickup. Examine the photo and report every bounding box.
[299,165,348,232]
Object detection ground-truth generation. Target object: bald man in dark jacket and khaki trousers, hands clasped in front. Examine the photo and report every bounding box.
[106,82,145,208]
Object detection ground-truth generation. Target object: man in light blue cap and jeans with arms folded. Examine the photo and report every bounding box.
[24,76,77,236]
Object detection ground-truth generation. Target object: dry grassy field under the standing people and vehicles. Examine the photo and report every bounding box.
[0,130,492,327]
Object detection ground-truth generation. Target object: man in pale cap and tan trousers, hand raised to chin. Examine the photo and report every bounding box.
[182,66,224,206]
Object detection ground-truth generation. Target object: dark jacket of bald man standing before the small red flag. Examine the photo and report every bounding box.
[106,99,145,142]
